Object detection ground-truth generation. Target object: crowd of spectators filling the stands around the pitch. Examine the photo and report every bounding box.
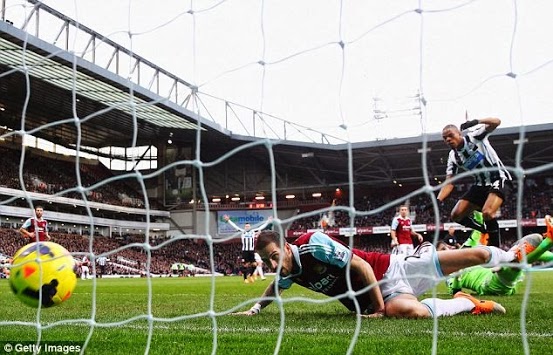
[0,143,553,275]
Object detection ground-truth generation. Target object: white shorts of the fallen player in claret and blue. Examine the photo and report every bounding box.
[380,243,443,302]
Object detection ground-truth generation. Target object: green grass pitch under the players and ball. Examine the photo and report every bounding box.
[0,270,553,355]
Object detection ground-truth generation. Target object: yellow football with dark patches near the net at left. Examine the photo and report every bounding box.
[10,242,77,308]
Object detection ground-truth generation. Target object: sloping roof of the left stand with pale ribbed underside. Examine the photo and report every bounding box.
[0,21,219,147]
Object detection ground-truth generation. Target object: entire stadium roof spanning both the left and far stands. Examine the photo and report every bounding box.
[0,14,553,193]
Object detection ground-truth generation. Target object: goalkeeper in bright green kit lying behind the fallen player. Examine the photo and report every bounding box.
[446,216,553,295]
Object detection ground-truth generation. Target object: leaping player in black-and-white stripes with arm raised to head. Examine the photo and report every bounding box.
[437,118,512,246]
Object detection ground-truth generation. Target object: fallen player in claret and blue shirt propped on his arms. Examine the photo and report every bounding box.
[235,231,542,318]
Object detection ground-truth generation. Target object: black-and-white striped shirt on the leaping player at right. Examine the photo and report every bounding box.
[446,125,512,186]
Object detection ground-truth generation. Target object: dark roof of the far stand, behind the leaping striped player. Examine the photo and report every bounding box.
[215,124,553,193]
